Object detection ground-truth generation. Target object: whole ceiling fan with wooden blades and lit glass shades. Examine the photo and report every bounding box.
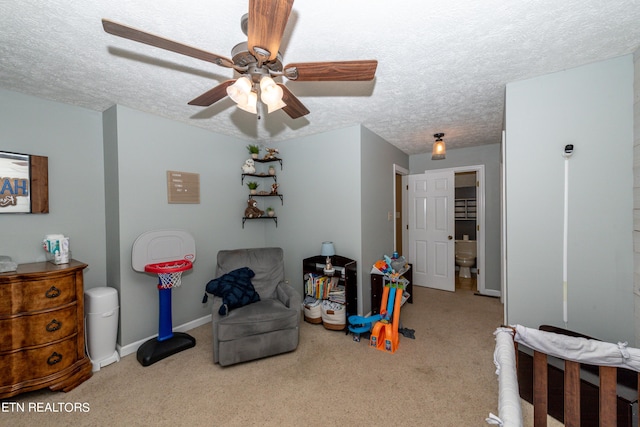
[102,0,378,119]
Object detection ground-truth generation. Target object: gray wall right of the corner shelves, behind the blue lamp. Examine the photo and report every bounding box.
[264,126,361,310]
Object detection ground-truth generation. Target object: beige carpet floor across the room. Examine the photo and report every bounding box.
[0,287,560,427]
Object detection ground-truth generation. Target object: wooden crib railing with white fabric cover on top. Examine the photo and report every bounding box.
[487,325,640,427]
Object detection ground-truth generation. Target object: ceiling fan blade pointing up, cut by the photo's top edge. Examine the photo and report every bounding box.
[247,0,293,61]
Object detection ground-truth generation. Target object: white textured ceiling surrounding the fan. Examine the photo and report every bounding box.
[0,0,640,154]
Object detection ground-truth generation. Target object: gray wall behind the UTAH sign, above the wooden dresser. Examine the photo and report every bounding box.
[0,89,106,288]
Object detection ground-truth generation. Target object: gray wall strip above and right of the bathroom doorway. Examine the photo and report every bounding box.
[409,142,501,292]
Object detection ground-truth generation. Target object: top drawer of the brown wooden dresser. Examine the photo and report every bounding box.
[0,275,76,316]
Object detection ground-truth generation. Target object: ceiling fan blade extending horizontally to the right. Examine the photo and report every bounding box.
[284,59,378,82]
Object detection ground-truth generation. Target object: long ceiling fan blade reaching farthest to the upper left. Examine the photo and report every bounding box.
[102,19,233,68]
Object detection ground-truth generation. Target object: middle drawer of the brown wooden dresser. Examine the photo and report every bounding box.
[0,302,78,352]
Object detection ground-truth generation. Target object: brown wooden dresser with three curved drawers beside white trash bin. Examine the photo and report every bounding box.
[0,260,92,399]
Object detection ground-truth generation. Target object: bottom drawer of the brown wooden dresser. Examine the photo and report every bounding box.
[0,335,78,386]
